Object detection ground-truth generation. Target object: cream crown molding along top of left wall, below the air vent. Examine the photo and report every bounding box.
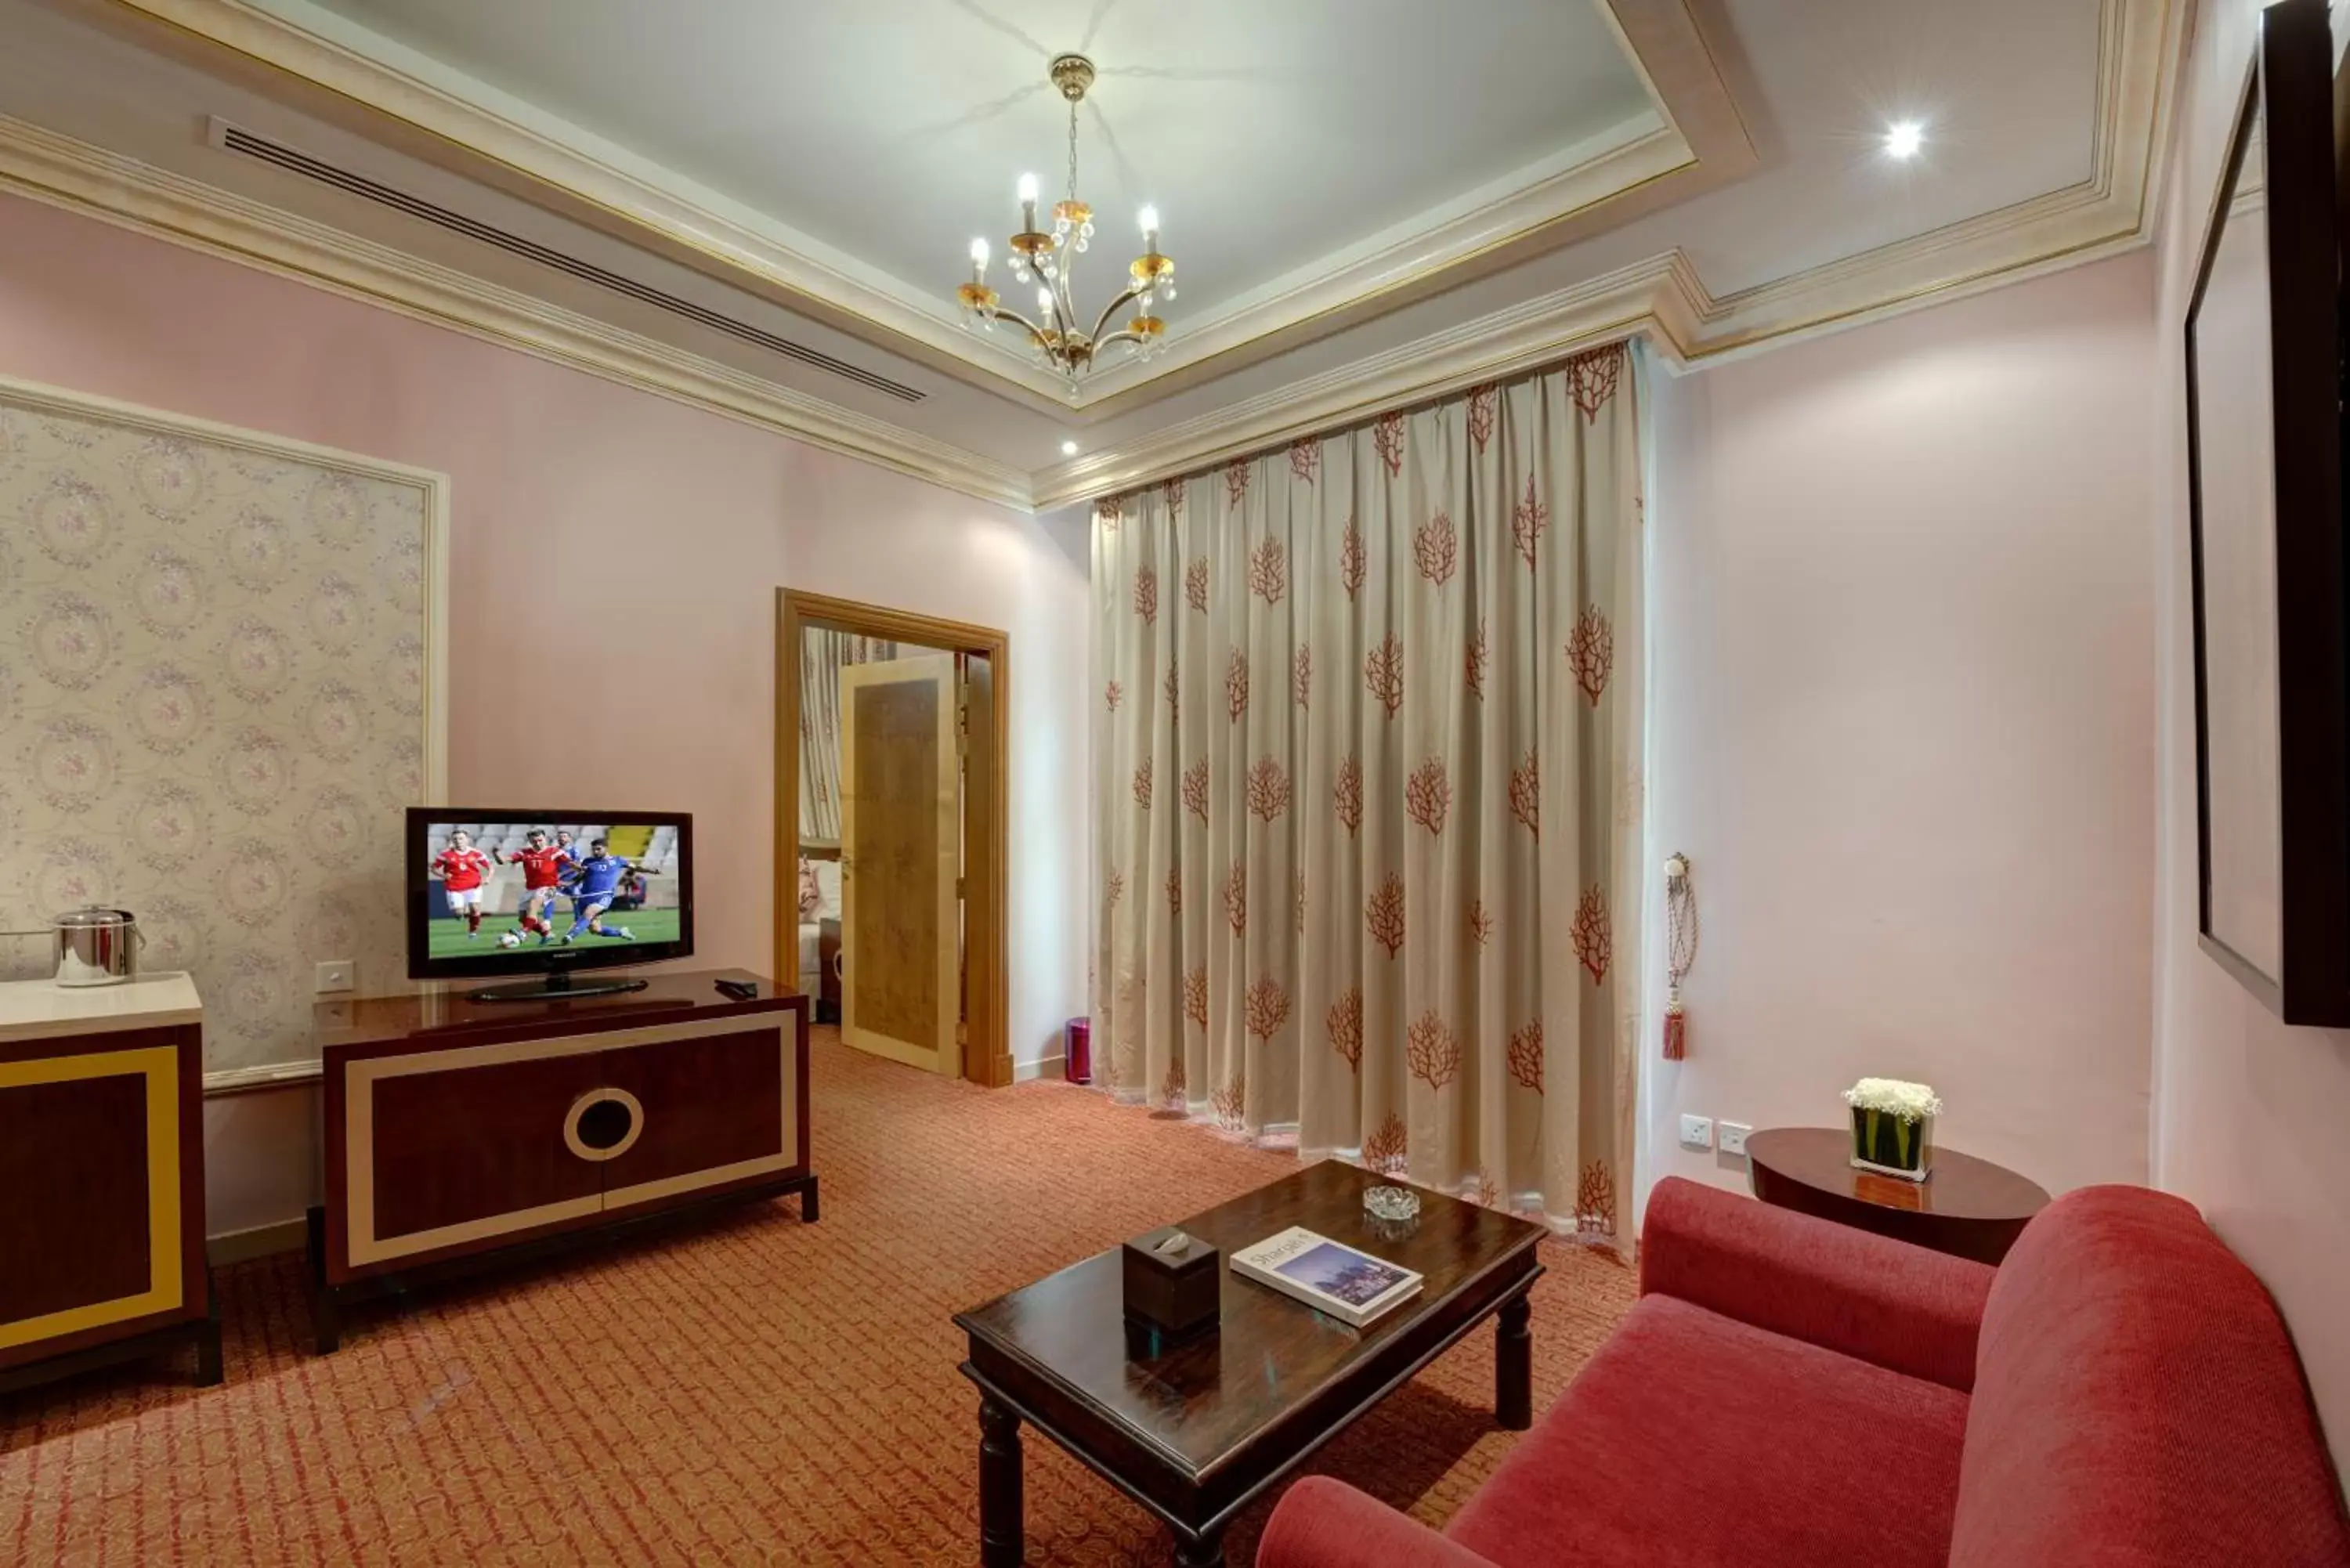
[0,115,1032,510]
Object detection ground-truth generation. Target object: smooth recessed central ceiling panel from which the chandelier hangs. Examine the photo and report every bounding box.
[289,0,1661,320]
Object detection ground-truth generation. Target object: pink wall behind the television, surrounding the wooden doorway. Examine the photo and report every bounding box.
[0,186,1088,1232]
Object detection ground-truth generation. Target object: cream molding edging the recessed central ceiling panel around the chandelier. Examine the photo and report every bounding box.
[103,0,1755,416]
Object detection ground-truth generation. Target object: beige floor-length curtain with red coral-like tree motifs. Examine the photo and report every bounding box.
[1093,345,1643,1237]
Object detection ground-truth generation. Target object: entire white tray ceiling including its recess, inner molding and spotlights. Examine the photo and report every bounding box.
[0,0,2188,496]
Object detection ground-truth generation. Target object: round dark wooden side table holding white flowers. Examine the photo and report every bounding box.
[1746,1126,2049,1265]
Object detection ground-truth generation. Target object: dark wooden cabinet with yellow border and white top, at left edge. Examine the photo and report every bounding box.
[0,974,221,1389]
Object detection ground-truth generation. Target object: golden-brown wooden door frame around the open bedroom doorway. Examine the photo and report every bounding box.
[776,587,1013,1089]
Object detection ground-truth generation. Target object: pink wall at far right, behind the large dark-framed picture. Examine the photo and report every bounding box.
[2153,0,2350,1469]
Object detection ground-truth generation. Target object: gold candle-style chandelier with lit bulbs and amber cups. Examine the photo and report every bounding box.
[954,54,1175,395]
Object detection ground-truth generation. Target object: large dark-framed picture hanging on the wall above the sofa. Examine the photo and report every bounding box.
[2186,0,2350,1025]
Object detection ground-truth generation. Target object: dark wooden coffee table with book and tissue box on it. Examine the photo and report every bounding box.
[954,1162,1546,1568]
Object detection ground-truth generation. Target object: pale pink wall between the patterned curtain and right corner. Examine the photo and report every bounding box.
[1643,254,2155,1192]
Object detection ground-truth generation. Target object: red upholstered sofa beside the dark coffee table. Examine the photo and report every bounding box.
[1257,1180,2350,1568]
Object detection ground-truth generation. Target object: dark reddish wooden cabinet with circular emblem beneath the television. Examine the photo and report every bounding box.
[313,971,818,1349]
